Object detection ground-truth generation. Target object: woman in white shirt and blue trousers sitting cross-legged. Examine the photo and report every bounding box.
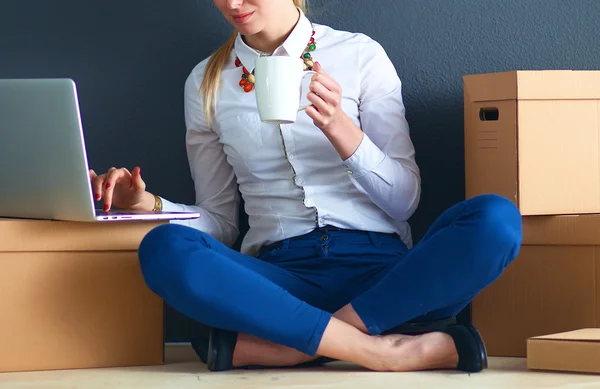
[91,0,521,372]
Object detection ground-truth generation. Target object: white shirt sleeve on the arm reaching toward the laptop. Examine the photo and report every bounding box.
[162,65,240,246]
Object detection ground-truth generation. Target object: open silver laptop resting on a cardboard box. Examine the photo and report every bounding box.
[0,79,200,221]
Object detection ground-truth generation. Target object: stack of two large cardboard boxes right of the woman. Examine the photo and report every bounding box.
[464,70,600,357]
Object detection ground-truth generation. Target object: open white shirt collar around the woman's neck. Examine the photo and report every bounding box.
[234,8,313,71]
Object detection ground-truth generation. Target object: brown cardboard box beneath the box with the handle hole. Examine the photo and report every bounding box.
[471,215,600,357]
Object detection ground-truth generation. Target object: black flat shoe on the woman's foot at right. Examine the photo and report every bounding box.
[441,324,488,373]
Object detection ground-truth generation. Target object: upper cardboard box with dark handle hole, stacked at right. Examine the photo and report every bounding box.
[464,70,600,215]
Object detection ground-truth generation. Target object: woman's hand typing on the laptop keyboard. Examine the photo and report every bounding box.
[90,167,154,211]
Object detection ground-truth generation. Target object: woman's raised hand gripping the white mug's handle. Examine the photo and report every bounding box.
[306,62,363,160]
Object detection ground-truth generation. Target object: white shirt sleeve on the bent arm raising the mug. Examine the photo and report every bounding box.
[343,40,421,221]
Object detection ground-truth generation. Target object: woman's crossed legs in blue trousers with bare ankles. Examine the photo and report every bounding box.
[140,195,521,371]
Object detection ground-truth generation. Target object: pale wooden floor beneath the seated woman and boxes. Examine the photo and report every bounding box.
[0,345,600,389]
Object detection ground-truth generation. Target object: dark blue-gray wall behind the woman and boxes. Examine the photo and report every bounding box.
[0,0,600,340]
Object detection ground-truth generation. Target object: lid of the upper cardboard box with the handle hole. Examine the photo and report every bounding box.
[463,70,600,102]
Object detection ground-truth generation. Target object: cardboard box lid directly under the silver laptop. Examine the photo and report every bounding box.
[0,218,167,252]
